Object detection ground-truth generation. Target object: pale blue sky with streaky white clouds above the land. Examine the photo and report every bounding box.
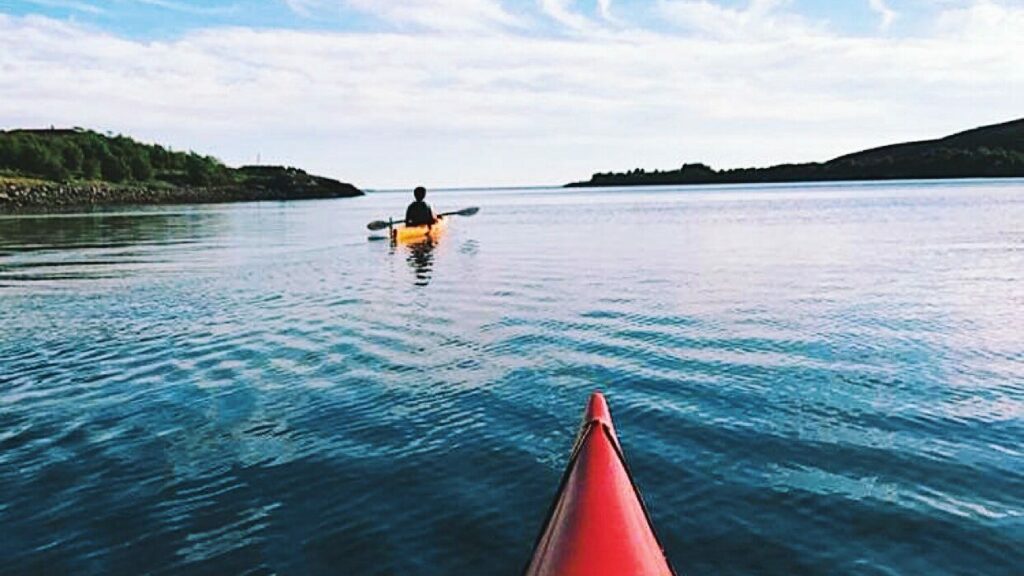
[0,0,1024,190]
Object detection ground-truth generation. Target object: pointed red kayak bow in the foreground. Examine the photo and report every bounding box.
[525,393,675,576]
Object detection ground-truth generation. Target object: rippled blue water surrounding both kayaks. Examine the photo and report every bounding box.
[0,180,1024,575]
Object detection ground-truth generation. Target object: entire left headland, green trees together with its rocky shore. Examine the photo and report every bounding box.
[0,128,364,211]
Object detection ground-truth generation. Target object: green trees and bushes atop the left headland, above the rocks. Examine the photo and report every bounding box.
[0,129,233,186]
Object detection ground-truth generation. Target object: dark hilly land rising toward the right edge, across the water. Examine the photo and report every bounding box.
[566,119,1024,187]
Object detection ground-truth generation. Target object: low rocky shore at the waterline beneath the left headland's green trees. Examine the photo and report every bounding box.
[0,175,362,211]
